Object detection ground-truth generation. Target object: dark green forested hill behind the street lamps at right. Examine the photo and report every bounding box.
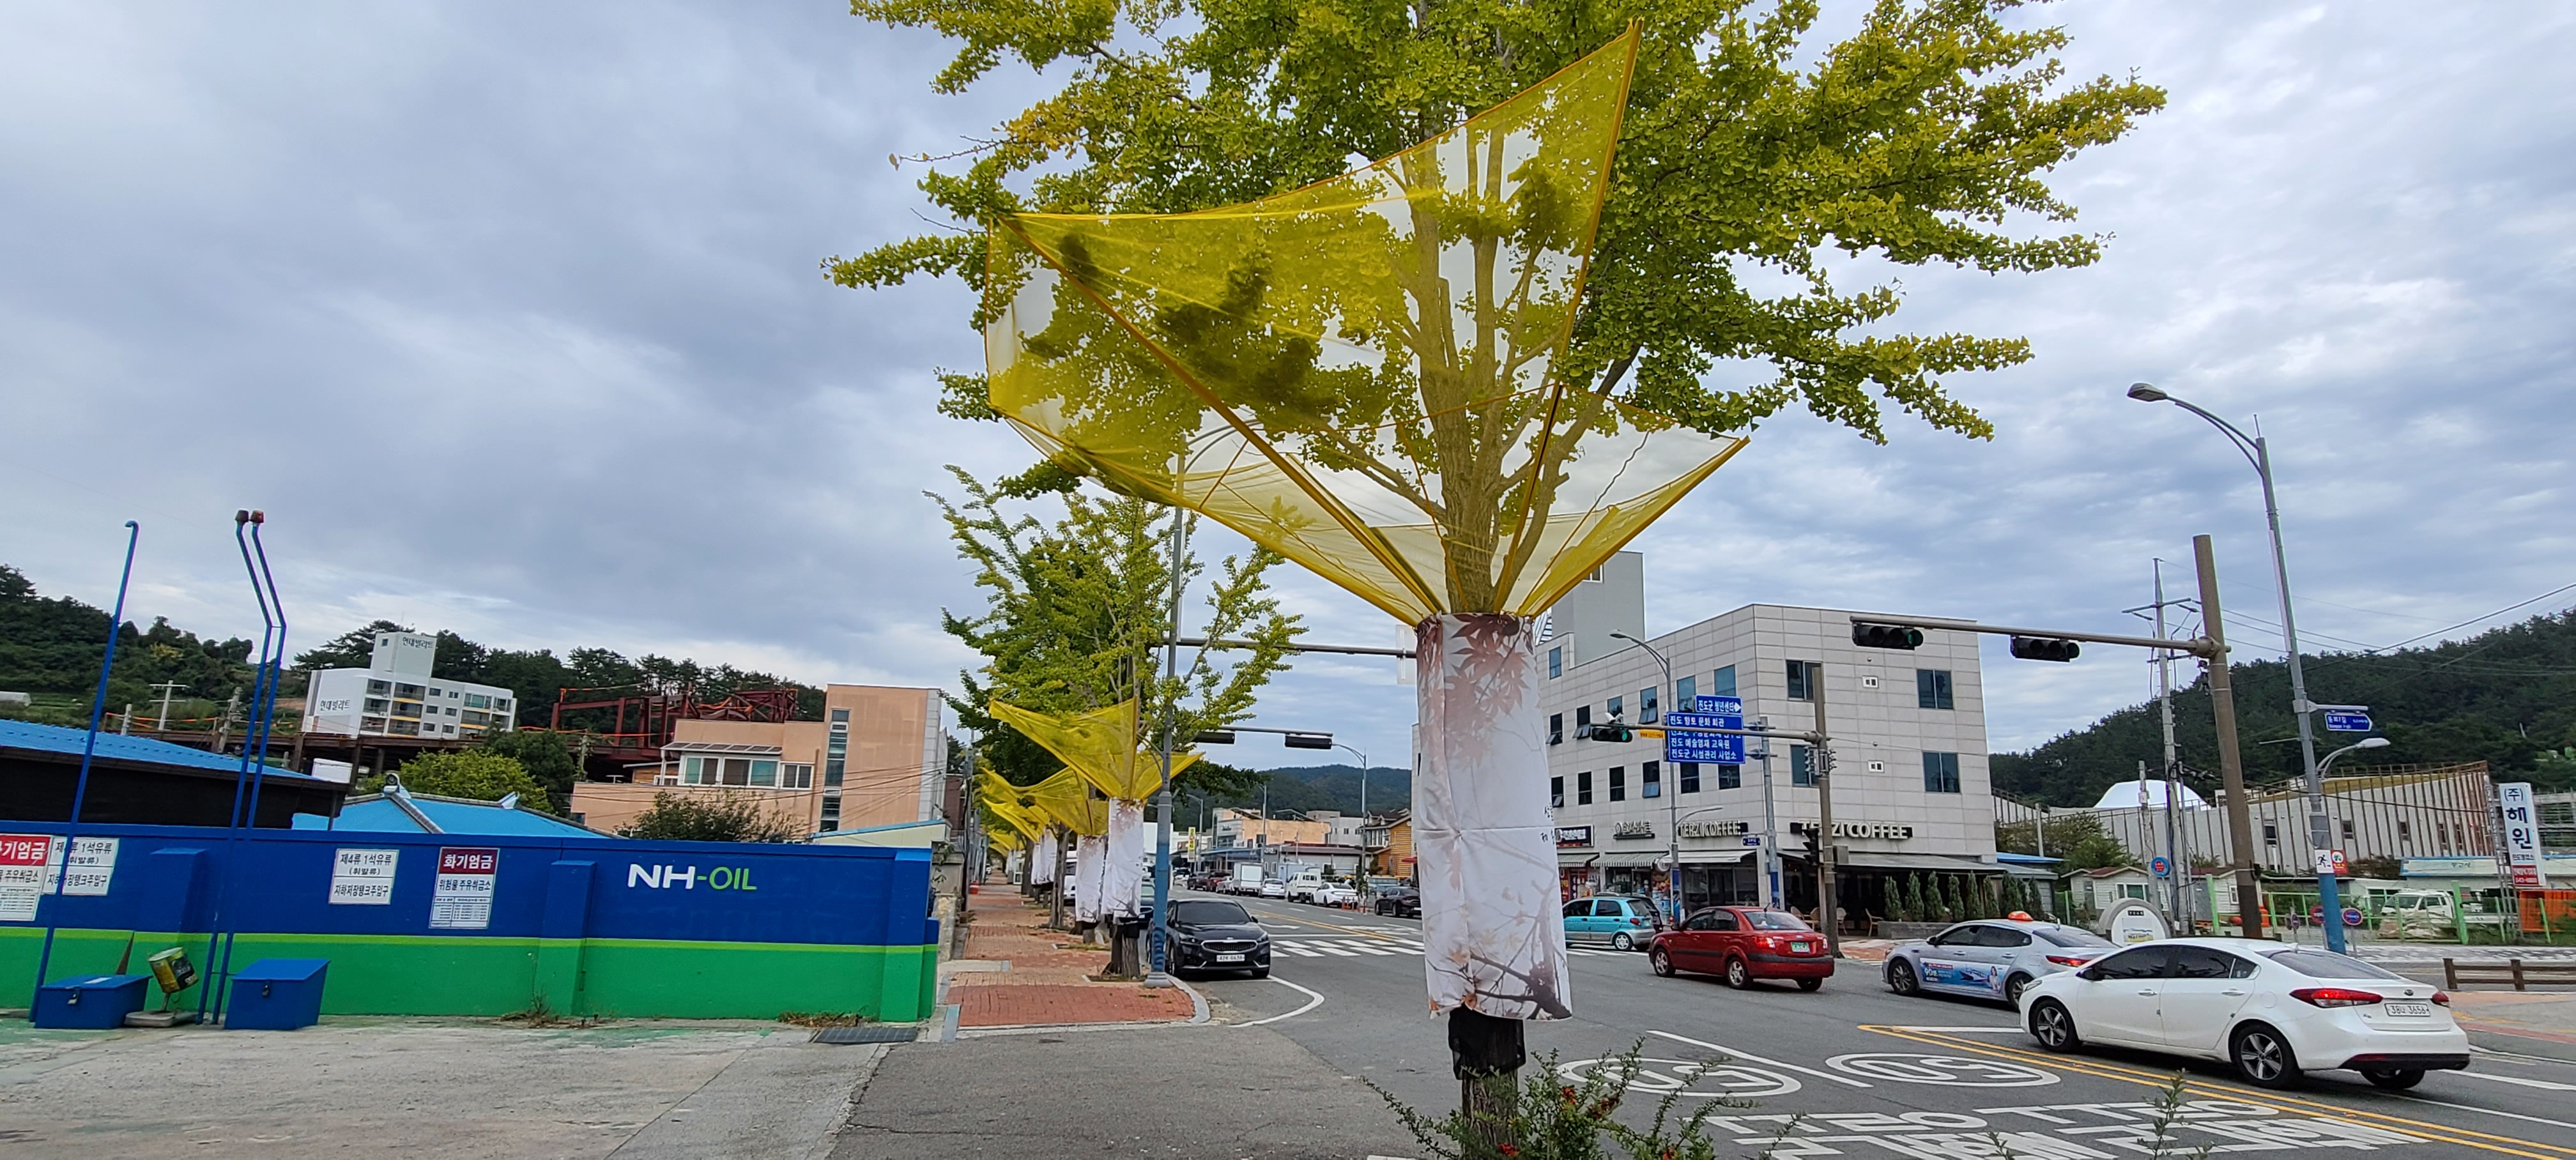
[1994,611,2576,807]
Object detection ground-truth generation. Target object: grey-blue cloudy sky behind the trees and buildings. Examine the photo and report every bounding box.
[0,3,2576,763]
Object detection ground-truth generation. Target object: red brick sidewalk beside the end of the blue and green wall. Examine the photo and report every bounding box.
[940,887,1198,1028]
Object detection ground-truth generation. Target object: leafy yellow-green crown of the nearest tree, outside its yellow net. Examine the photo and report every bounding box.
[824,0,2164,485]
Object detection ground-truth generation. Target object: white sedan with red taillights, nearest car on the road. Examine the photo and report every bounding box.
[2022,938,2468,1090]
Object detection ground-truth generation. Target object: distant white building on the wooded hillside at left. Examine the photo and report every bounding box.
[304,632,518,740]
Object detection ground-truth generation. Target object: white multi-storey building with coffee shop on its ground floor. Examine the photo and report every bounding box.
[1540,552,2045,915]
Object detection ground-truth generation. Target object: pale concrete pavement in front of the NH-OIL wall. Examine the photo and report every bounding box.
[0,1018,884,1160]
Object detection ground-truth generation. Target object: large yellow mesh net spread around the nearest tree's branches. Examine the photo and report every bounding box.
[984,28,1744,624]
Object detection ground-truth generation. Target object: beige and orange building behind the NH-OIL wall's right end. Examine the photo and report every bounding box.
[572,685,948,832]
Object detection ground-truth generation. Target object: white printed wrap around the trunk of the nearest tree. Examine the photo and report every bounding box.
[1414,613,1574,1018]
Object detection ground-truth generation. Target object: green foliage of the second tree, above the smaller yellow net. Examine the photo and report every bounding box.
[933,466,1301,794]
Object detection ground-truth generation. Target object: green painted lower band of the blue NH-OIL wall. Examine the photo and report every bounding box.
[0,928,938,1023]
